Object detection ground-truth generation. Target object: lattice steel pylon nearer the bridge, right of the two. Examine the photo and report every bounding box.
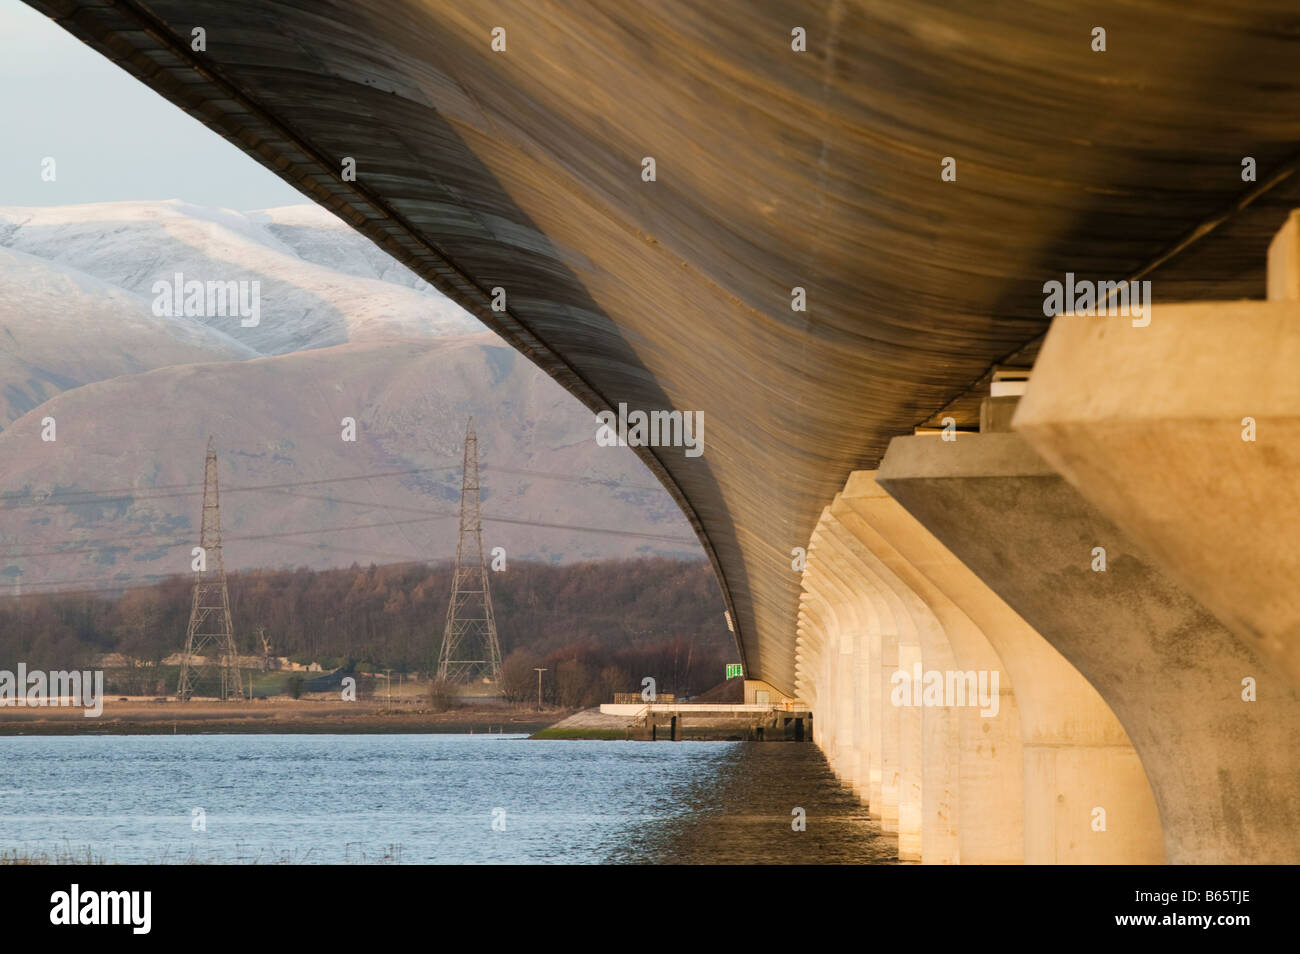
[438,417,501,685]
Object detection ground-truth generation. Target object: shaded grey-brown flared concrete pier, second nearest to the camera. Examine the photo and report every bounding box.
[878,426,1300,863]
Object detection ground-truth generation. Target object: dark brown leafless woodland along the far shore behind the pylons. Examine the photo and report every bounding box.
[0,558,738,706]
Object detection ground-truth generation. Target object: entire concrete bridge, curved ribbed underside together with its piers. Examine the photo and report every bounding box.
[27,0,1300,862]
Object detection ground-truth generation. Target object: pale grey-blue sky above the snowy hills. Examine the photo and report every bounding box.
[0,0,302,212]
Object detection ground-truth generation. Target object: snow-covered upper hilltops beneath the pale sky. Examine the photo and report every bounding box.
[0,200,482,355]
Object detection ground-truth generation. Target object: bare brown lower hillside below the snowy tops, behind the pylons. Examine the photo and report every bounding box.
[0,333,699,591]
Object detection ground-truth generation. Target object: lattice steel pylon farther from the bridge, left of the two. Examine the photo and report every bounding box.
[176,438,243,702]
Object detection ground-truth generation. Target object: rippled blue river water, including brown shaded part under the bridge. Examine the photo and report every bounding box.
[0,734,897,864]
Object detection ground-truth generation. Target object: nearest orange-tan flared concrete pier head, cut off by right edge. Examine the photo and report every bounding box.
[1014,214,1300,691]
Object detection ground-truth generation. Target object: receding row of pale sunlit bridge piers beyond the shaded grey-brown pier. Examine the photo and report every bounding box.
[800,472,1164,863]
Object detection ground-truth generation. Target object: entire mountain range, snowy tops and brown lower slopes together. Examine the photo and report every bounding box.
[0,201,701,595]
